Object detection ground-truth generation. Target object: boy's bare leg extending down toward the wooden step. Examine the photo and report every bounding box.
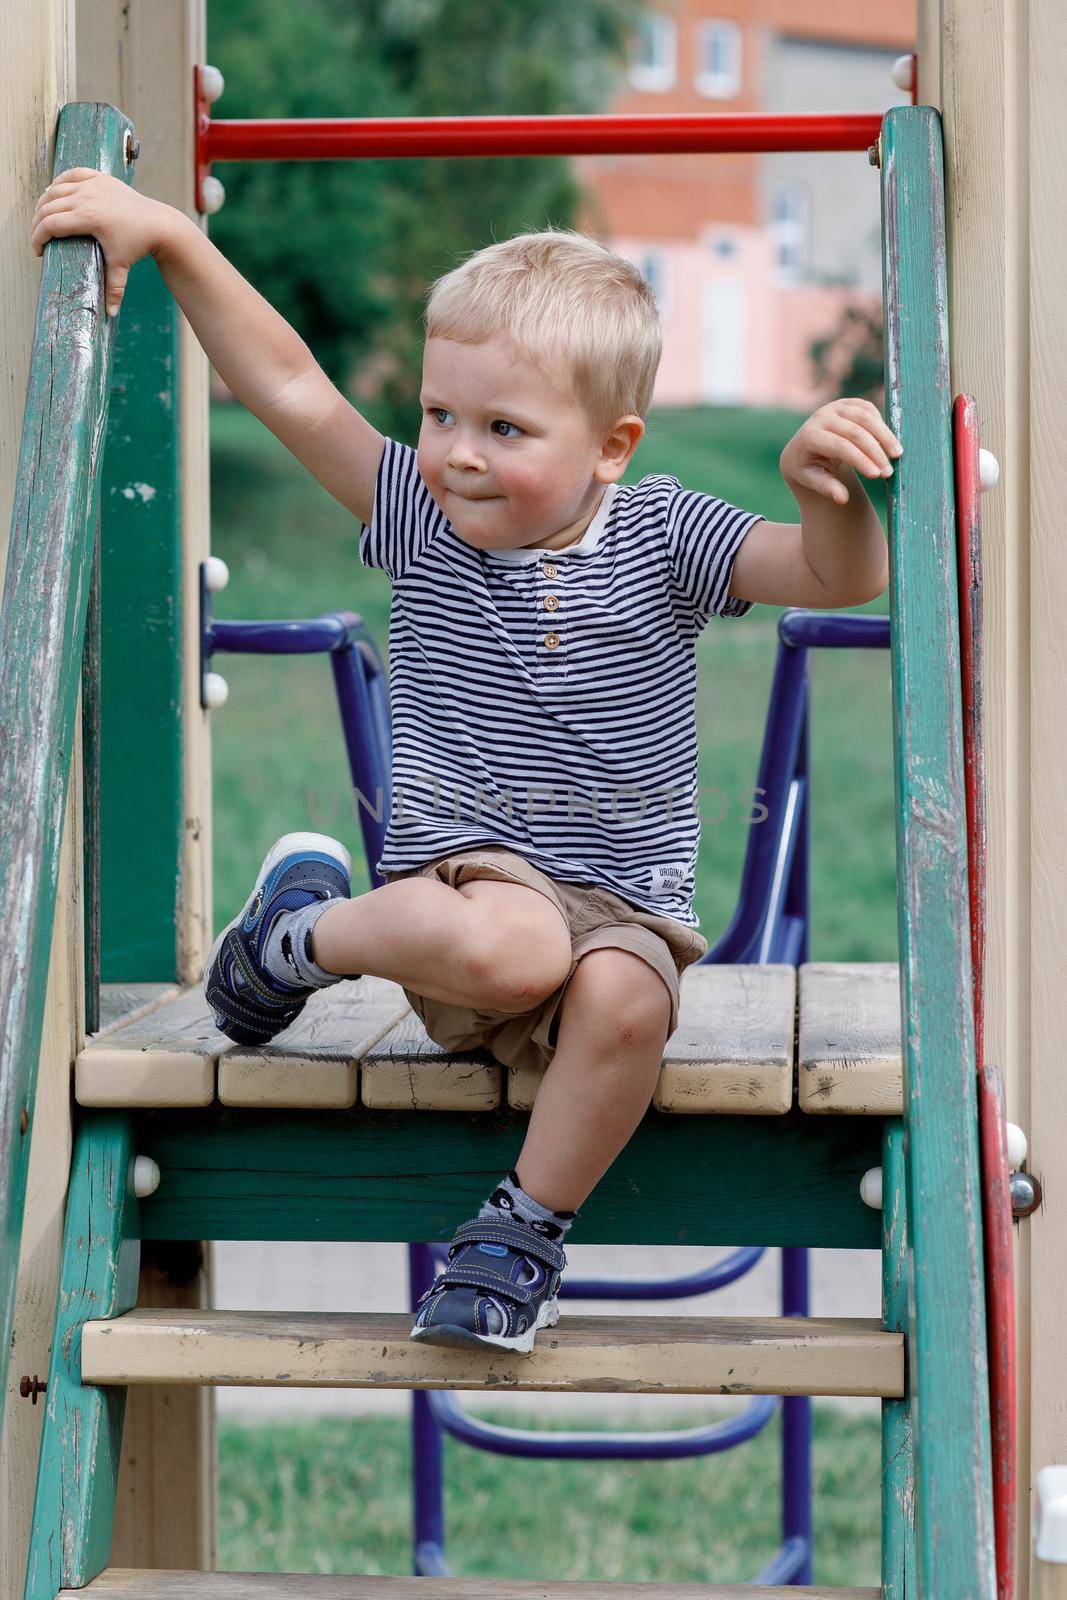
[515,949,670,1211]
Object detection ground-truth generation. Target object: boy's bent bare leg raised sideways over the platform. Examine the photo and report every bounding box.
[310,877,571,1013]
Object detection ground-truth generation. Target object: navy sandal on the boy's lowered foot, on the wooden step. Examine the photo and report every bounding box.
[411,1216,566,1355]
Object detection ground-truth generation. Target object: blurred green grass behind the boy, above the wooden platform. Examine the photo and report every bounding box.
[211,405,896,962]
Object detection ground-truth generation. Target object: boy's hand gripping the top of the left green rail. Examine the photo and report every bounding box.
[30,166,171,317]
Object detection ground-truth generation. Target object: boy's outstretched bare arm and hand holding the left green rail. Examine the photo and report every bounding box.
[30,166,384,522]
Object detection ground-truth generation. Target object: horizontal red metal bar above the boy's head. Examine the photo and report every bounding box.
[202,112,881,162]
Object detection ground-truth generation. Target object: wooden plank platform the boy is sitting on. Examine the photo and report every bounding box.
[75,963,902,1117]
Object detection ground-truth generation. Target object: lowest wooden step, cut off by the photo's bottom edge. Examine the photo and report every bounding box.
[58,1566,881,1600]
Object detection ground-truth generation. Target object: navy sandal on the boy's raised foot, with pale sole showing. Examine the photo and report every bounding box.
[205,834,352,1045]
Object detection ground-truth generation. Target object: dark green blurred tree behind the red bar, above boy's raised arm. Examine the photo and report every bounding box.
[210,0,643,438]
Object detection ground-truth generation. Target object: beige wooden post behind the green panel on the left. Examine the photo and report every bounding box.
[76,0,216,1590]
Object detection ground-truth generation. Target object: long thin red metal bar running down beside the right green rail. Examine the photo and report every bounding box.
[952,395,1016,1600]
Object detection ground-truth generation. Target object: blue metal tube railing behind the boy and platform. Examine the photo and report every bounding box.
[200,588,889,1586]
